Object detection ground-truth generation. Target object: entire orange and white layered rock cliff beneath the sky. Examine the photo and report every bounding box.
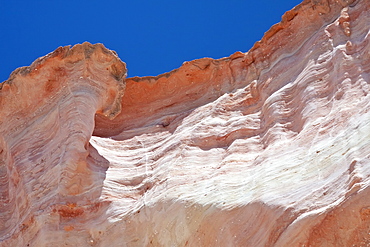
[0,0,370,246]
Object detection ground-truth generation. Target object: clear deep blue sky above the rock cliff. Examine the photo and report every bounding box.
[0,0,301,82]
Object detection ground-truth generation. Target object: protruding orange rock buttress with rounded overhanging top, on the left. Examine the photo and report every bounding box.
[0,43,126,246]
